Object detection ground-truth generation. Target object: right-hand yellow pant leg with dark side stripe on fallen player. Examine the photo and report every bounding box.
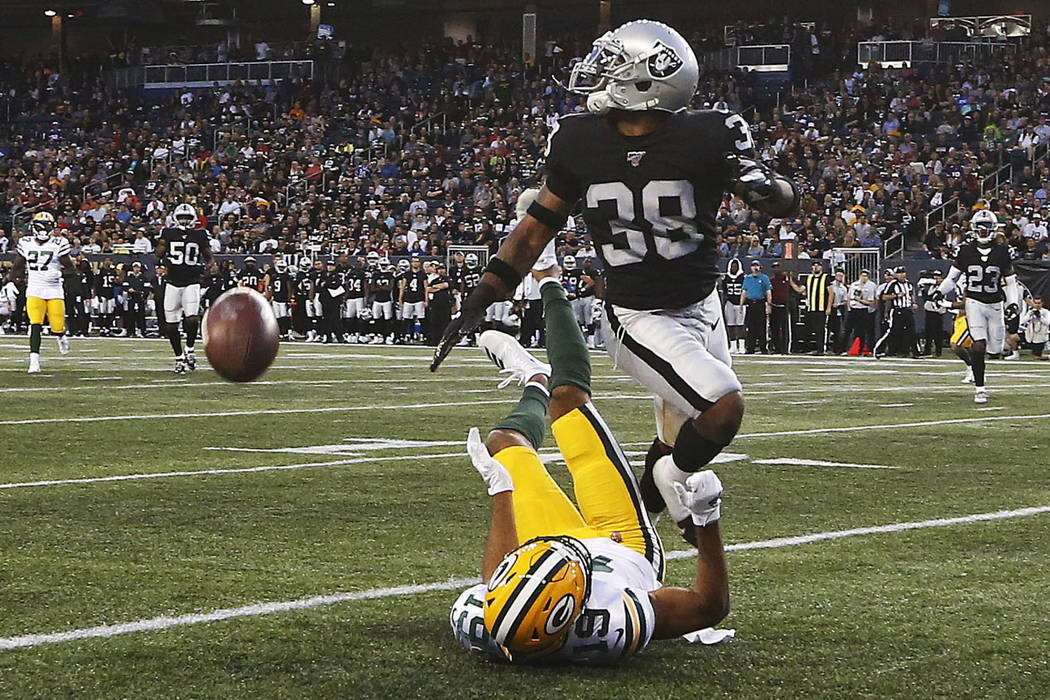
[550,403,664,579]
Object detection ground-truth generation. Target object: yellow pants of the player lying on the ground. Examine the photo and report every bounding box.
[495,403,664,579]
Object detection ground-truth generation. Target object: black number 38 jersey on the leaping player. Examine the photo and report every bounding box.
[546,110,754,309]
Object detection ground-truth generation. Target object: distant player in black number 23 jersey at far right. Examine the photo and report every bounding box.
[935,209,1021,403]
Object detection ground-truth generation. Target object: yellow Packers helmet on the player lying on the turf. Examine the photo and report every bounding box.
[485,536,591,661]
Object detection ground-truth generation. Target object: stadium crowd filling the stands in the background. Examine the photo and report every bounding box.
[0,17,1050,356]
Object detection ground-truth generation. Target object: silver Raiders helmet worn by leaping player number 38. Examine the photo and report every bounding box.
[568,20,700,114]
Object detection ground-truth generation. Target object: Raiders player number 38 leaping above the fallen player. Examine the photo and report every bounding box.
[432,20,799,533]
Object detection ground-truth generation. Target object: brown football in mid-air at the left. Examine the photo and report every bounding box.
[202,287,280,382]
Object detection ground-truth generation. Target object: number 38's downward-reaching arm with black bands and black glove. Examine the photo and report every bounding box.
[431,186,573,372]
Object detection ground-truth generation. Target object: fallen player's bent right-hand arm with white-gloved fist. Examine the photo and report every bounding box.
[650,469,729,639]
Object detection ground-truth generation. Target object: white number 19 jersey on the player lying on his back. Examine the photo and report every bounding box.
[449,537,660,663]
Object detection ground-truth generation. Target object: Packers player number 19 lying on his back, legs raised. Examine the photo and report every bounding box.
[450,262,729,663]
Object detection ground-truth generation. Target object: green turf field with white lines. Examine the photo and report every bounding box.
[0,336,1050,700]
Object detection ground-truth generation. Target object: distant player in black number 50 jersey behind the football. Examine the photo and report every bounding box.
[153,204,211,375]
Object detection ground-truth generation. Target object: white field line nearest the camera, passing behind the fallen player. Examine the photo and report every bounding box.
[0,506,1050,651]
